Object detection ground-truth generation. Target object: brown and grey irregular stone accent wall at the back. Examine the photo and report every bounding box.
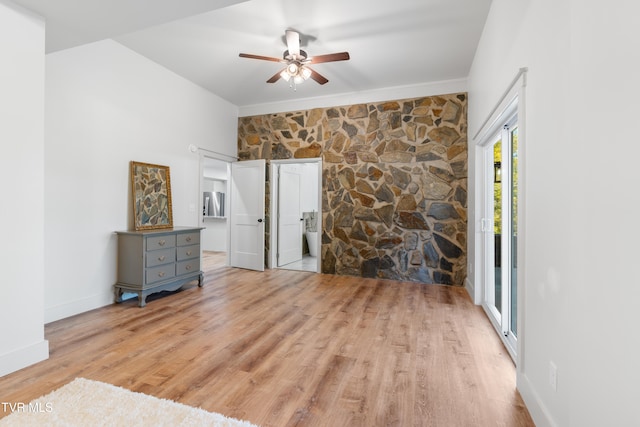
[238,93,467,285]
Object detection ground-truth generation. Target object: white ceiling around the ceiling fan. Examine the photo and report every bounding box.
[12,0,491,107]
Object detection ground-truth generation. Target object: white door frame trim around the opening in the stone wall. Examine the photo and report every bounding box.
[267,157,322,273]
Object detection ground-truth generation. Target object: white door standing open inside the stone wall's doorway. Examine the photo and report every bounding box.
[277,164,302,267]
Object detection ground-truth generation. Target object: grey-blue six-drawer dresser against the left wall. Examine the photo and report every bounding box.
[113,227,204,307]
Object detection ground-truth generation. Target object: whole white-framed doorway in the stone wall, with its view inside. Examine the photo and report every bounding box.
[269,158,322,272]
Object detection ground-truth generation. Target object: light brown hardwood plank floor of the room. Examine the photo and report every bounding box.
[0,253,533,427]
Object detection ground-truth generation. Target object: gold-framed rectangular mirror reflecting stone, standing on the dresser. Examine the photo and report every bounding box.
[131,161,173,231]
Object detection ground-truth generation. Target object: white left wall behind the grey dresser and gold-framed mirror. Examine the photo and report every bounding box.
[44,40,238,322]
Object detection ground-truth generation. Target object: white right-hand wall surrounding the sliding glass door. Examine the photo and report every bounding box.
[469,0,640,427]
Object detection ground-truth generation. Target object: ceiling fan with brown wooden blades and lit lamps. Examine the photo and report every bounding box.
[240,30,349,85]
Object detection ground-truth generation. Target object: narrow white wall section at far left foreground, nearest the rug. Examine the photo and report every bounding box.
[0,0,49,376]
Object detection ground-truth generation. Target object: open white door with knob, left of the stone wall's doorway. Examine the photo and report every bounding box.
[229,160,265,271]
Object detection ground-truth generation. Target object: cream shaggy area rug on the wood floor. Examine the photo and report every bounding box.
[0,378,256,427]
